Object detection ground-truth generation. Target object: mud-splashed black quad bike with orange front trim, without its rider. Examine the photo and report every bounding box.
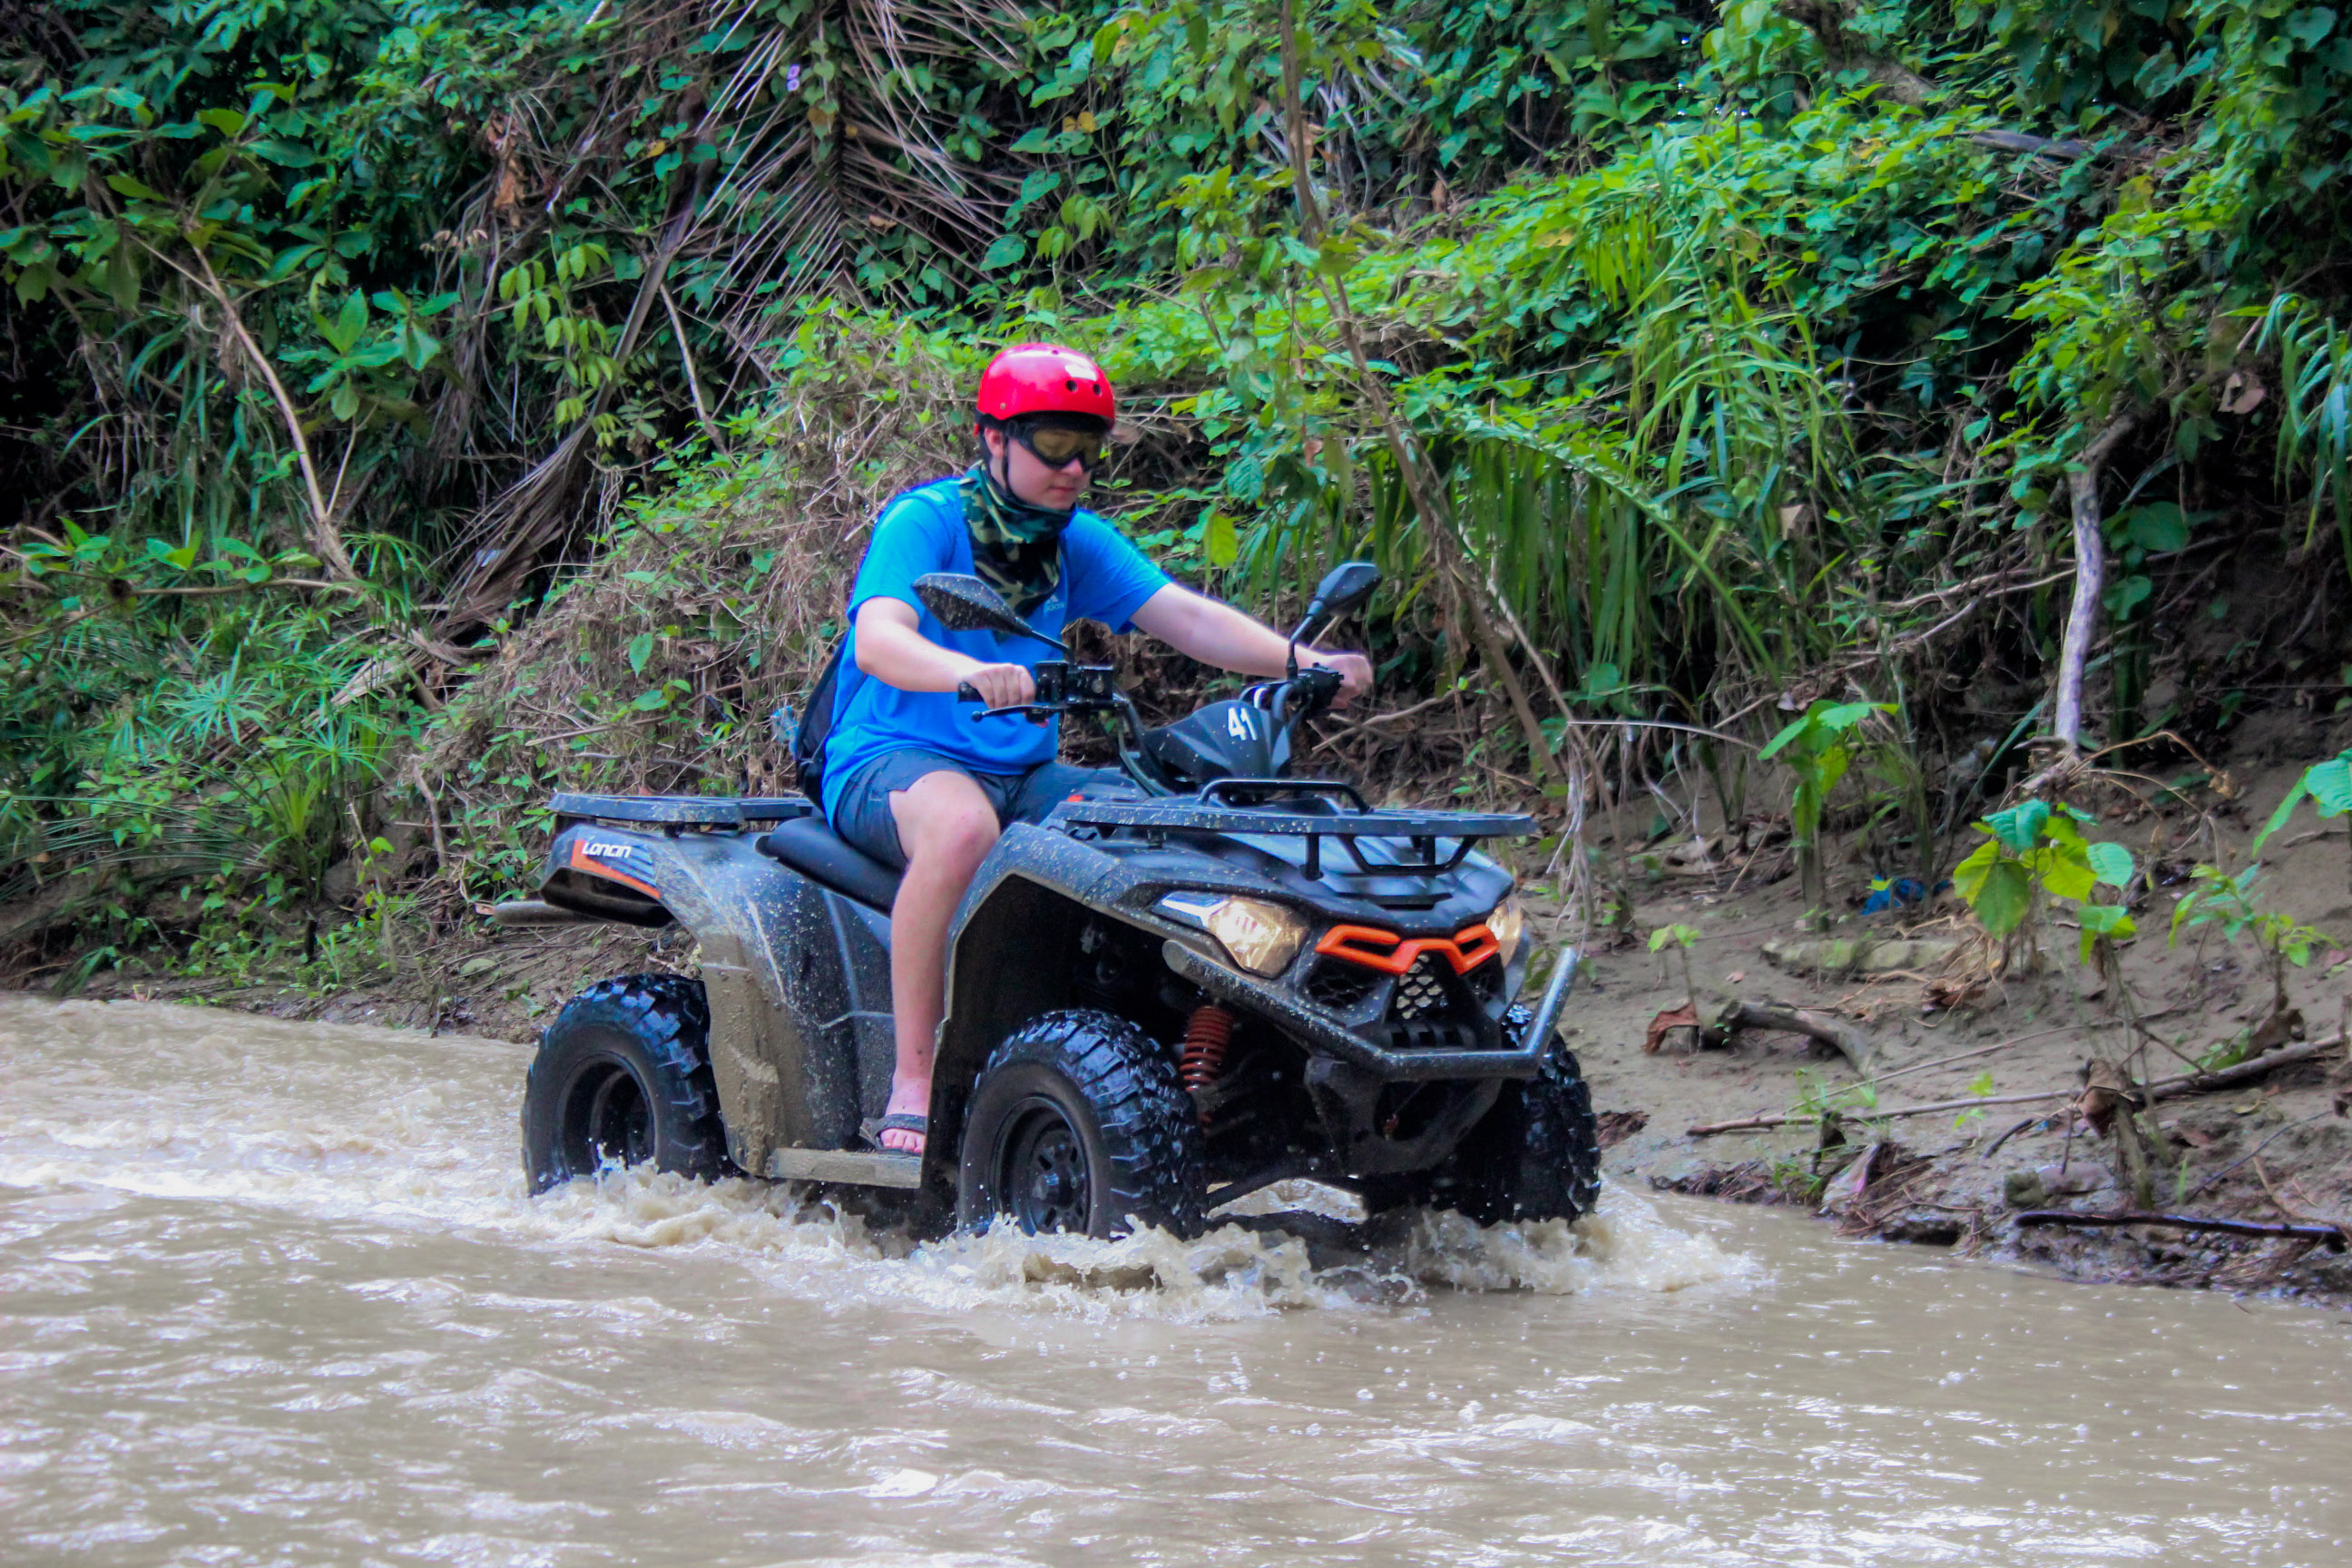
[496,562,1600,1237]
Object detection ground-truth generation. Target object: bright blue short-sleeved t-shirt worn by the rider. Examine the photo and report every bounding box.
[823,477,1169,816]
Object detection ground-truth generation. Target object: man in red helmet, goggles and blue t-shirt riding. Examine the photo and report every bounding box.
[811,343,1371,1154]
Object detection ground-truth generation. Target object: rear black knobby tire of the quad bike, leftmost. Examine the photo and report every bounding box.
[522,975,731,1191]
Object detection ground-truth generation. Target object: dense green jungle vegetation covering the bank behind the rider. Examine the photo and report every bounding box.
[0,0,2352,983]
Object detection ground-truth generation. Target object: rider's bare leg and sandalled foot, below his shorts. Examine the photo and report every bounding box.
[882,771,997,1154]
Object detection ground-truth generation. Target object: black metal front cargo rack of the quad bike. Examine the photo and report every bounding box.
[1054,779,1536,877]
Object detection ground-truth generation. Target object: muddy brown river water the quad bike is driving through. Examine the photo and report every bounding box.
[0,996,2352,1568]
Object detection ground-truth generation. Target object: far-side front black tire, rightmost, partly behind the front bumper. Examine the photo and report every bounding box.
[1433,1006,1602,1225]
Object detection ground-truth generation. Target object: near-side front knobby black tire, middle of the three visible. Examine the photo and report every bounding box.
[955,1008,1207,1237]
